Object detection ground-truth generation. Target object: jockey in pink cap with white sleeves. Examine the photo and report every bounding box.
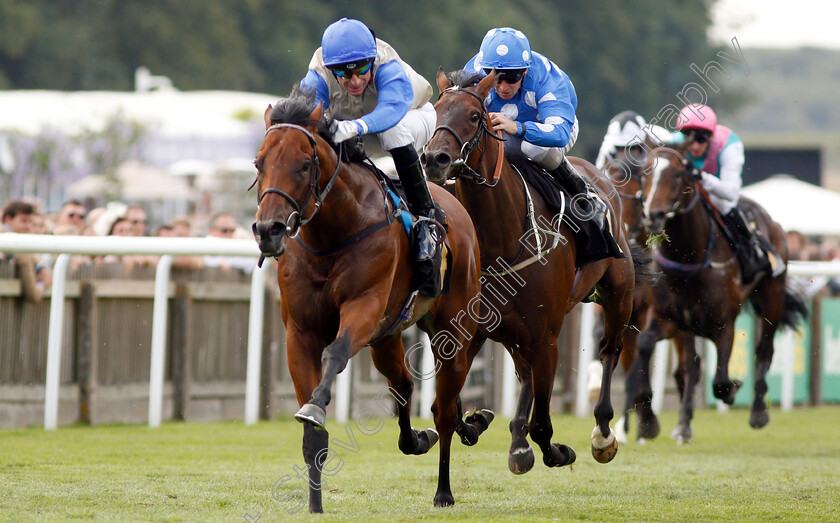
[677,104,784,284]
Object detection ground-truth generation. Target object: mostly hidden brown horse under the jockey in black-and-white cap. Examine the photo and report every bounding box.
[604,144,699,443]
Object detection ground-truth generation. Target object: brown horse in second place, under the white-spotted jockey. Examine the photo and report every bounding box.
[421,70,635,474]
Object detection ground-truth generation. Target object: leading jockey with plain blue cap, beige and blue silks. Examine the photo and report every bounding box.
[301,18,437,262]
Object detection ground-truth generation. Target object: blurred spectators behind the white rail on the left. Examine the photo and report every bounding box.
[0,198,255,302]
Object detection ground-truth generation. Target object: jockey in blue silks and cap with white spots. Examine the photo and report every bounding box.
[464,27,607,224]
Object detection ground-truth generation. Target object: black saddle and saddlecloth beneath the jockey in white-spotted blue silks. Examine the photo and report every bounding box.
[508,157,625,268]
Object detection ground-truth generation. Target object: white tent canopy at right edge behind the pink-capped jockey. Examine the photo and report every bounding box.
[741,174,840,236]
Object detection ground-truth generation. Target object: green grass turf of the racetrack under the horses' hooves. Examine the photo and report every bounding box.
[0,406,840,522]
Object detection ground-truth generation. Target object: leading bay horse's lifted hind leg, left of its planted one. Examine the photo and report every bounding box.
[370,335,438,455]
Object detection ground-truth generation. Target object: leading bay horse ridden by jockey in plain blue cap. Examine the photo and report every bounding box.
[253,90,486,512]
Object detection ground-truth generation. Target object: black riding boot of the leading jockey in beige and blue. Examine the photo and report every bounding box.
[390,145,439,262]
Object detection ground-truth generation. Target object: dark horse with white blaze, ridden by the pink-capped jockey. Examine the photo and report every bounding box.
[638,143,807,441]
